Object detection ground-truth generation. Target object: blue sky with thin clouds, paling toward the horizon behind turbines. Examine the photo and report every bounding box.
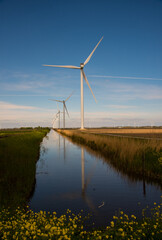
[0,0,162,128]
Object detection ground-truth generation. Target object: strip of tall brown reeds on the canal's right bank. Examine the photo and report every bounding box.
[58,130,162,184]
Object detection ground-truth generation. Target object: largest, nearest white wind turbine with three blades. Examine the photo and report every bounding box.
[43,37,103,129]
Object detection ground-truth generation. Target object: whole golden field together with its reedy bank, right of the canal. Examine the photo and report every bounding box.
[58,129,162,185]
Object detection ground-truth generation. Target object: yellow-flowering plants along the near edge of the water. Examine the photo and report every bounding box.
[0,203,162,240]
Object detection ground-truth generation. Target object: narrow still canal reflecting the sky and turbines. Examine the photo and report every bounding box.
[29,130,162,226]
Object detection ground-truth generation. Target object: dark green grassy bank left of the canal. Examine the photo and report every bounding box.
[0,128,49,209]
